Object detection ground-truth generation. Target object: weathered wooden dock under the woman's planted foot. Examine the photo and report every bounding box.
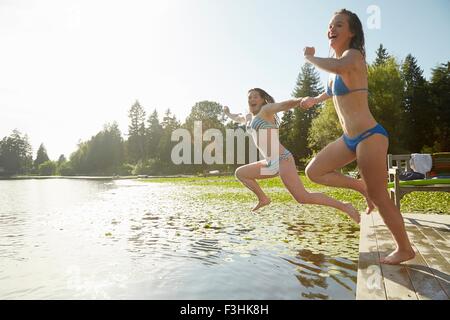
[356,213,450,300]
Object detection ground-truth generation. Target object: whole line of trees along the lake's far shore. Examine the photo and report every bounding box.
[0,45,450,176]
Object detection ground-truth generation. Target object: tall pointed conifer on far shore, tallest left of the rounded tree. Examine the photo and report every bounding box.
[127,100,147,163]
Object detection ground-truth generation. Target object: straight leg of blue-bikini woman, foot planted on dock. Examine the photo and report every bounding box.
[356,134,414,264]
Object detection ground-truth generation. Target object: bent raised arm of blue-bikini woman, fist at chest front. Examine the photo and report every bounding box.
[303,47,362,74]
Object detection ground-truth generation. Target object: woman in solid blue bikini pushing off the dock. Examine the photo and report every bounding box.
[301,9,415,264]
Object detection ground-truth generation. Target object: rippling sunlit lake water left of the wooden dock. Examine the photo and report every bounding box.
[0,180,358,299]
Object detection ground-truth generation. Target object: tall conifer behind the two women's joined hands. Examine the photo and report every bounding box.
[292,63,324,166]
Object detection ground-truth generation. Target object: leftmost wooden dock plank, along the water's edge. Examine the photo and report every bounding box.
[356,215,386,300]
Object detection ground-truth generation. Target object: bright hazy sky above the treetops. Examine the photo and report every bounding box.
[0,0,450,160]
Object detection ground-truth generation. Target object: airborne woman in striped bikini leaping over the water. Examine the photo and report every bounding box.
[224,88,360,223]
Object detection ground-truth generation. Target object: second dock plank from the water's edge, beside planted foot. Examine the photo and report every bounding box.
[372,213,418,300]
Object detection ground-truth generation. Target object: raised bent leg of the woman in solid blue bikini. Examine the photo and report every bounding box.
[305,137,374,213]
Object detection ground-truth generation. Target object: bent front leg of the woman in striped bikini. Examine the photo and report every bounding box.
[235,160,278,211]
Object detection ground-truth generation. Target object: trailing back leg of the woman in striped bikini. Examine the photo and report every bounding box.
[280,156,360,223]
